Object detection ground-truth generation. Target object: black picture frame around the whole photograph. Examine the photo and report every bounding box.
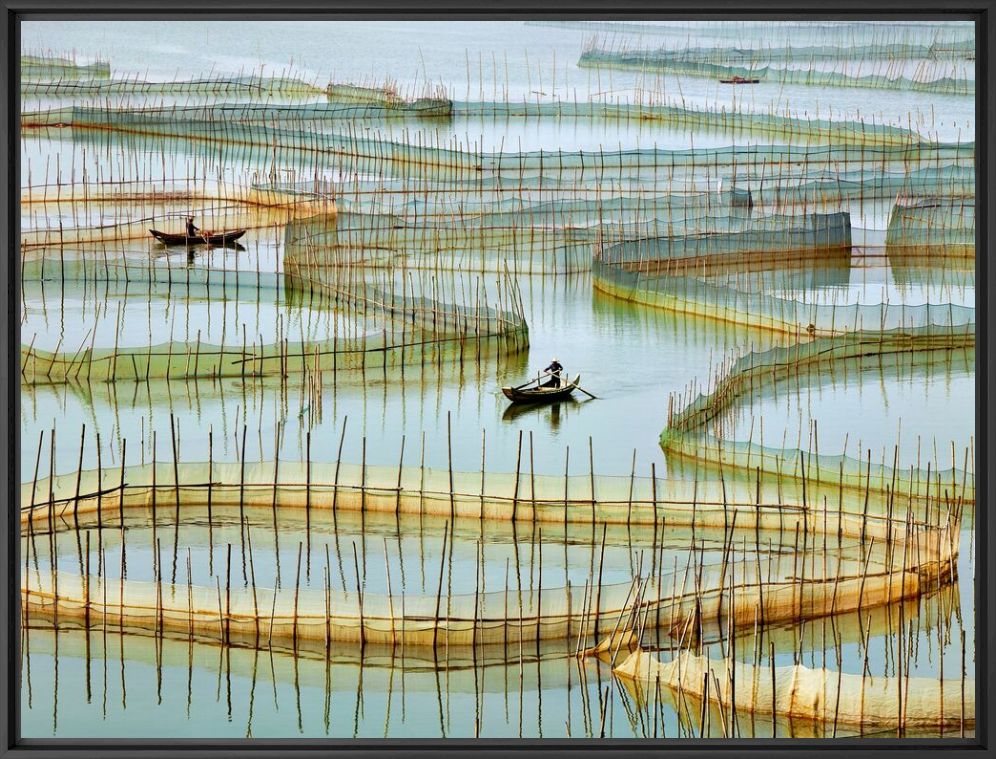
[0,0,996,759]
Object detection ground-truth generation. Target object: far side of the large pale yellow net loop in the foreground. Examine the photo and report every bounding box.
[21,448,959,543]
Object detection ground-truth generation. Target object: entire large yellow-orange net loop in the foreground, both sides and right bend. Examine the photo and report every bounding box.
[21,462,958,645]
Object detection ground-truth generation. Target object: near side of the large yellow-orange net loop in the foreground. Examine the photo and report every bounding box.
[22,506,955,646]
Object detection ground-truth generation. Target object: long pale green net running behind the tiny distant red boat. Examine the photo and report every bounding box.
[578,49,975,95]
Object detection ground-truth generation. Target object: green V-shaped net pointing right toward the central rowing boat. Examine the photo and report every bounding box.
[21,257,528,384]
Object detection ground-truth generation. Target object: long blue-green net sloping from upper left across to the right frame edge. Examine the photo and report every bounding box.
[22,114,975,186]
